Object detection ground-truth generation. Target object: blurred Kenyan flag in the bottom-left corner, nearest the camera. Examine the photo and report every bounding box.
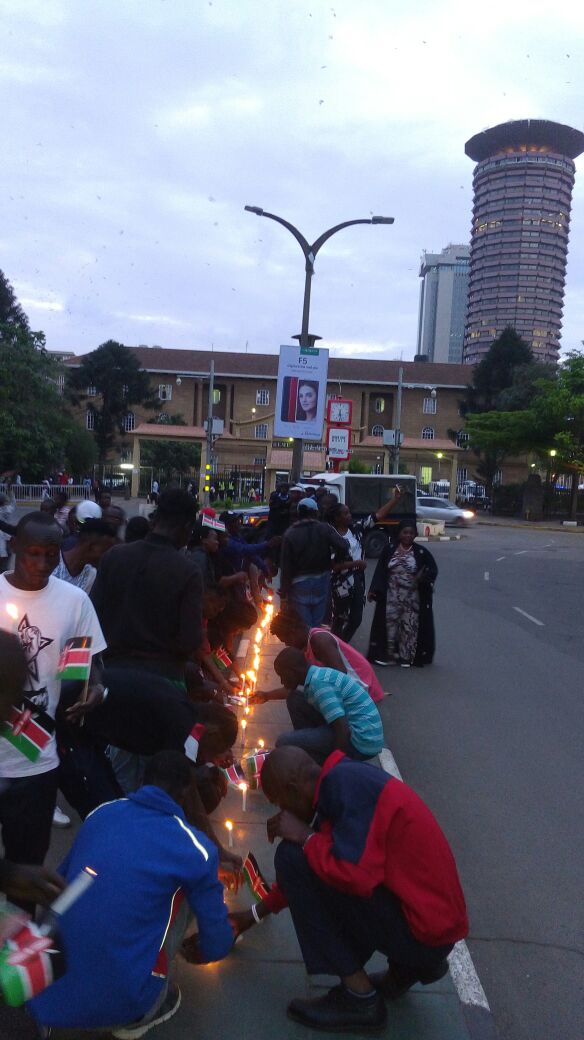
[0,921,64,1008]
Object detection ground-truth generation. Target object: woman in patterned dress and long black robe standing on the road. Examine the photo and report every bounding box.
[368,521,437,668]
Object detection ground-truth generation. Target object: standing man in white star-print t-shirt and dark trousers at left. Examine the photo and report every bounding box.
[0,513,106,906]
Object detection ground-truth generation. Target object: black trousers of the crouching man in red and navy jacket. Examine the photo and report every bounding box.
[275,841,452,979]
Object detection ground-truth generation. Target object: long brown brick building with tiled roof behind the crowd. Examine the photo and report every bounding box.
[65,346,525,491]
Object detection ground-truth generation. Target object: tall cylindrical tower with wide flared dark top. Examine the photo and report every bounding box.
[463,120,584,364]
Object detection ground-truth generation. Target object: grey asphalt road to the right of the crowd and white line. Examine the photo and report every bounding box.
[355,526,584,1040]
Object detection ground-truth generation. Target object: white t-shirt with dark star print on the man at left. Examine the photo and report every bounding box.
[0,574,107,778]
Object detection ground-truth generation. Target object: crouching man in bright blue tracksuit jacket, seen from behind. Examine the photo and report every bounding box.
[27,751,234,1040]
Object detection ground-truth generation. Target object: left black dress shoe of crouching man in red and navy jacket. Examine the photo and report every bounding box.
[288,986,388,1033]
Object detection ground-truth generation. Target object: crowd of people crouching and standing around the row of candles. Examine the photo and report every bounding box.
[0,486,467,1040]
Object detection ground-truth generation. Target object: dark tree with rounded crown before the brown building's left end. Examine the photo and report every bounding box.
[69,339,158,474]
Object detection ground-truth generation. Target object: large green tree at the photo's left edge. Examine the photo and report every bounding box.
[0,321,72,480]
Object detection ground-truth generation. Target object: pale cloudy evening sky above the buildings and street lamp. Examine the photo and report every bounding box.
[0,0,584,360]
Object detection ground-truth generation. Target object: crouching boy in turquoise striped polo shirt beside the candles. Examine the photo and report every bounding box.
[257,647,383,763]
